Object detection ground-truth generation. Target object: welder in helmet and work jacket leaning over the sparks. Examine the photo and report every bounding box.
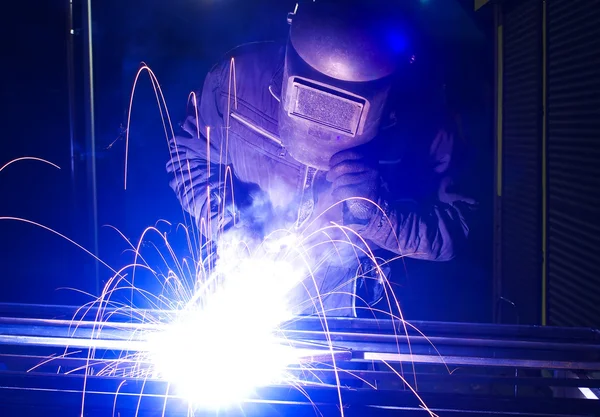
[167,0,475,316]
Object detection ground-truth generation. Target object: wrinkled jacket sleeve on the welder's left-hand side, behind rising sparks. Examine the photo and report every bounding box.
[167,62,235,236]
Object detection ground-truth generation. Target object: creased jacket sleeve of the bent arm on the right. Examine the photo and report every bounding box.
[359,130,476,261]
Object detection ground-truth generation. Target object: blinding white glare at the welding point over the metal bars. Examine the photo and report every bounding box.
[148,236,302,408]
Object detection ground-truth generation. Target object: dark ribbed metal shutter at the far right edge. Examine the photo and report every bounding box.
[547,0,600,328]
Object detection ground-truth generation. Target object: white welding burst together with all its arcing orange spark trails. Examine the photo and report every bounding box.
[0,59,440,417]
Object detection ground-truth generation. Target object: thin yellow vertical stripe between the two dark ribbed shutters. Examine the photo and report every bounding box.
[542,1,548,326]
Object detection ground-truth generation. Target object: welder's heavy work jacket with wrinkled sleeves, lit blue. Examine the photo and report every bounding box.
[167,42,475,316]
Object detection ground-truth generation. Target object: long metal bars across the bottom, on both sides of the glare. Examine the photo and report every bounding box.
[0,304,600,417]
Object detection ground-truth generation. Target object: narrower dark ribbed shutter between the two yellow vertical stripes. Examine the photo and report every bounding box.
[499,0,542,324]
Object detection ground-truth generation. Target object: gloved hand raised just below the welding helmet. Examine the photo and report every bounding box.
[327,148,380,222]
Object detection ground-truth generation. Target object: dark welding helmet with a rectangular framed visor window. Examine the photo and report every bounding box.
[279,0,413,170]
